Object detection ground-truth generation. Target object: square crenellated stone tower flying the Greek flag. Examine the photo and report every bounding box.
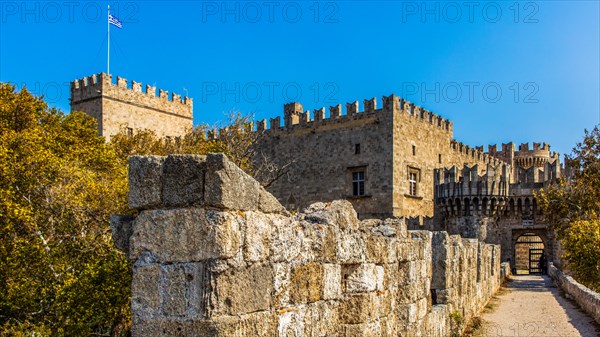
[71,73,193,139]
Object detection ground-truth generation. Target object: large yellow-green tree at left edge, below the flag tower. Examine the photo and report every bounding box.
[0,83,131,336]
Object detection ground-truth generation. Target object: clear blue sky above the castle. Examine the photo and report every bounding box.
[0,0,600,153]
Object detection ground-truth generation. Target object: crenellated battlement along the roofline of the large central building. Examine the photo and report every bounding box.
[257,94,453,133]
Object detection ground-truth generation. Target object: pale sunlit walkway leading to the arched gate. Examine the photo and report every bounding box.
[482,275,600,337]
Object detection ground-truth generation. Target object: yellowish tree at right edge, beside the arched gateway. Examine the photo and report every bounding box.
[537,127,600,291]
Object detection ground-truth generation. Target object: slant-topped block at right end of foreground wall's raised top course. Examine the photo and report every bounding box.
[204,153,260,211]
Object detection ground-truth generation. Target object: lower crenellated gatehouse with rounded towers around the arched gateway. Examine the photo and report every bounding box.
[426,164,560,269]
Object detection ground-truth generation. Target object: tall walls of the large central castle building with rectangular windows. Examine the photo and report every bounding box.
[258,95,502,218]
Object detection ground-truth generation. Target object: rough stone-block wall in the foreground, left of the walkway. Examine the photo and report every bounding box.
[111,154,502,337]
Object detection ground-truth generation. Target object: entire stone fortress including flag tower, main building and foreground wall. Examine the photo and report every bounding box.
[71,74,563,337]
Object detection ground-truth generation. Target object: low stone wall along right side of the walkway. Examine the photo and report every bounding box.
[548,263,600,324]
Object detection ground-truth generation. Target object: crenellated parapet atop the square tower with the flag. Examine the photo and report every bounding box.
[71,73,193,118]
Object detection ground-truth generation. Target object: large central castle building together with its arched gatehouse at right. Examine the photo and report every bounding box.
[257,95,563,270]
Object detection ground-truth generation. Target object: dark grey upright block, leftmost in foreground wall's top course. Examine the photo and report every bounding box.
[129,156,166,210]
